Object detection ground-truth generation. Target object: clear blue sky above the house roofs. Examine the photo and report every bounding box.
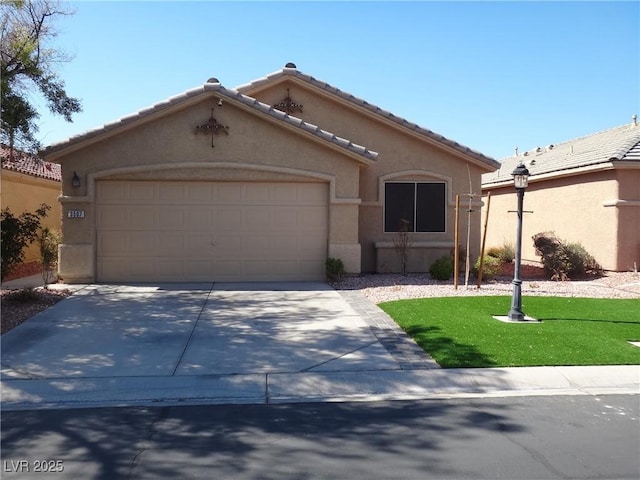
[39,1,640,160]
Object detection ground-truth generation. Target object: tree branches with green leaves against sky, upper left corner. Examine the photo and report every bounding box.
[0,0,81,157]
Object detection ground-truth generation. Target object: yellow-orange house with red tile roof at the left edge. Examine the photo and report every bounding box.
[0,145,61,278]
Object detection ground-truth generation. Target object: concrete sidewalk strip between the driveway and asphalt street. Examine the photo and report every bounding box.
[2,365,640,411]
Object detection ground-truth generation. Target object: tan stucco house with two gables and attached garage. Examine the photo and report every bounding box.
[46,64,499,282]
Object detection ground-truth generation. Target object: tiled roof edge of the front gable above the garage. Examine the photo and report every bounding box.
[45,79,378,162]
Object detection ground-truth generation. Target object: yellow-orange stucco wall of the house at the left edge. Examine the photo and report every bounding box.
[0,169,61,263]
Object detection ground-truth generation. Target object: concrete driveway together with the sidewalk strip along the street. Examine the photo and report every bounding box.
[2,283,640,410]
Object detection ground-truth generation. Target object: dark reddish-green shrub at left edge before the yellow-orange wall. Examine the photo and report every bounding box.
[0,203,51,278]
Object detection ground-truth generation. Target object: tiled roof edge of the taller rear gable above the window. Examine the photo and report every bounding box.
[235,64,500,169]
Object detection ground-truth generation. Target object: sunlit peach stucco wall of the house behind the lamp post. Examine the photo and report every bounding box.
[483,170,638,270]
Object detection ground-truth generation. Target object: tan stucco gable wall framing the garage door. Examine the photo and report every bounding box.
[52,96,361,281]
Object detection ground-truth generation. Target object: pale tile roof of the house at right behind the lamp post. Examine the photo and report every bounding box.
[482,122,640,186]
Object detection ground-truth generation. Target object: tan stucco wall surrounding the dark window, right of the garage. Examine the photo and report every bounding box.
[249,80,487,272]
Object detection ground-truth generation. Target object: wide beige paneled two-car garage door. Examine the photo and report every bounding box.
[96,181,328,282]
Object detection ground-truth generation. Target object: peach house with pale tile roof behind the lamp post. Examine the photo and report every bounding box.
[482,116,640,271]
